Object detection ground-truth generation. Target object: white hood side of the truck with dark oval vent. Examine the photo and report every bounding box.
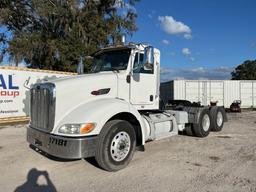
[50,71,118,122]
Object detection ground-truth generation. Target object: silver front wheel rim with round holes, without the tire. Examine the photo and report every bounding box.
[110,131,131,161]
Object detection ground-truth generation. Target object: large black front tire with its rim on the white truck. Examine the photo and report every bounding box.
[95,120,136,171]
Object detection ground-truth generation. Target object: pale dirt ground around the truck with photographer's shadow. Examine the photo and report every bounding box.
[0,112,256,192]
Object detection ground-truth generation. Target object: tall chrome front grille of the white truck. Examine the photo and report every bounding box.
[30,83,56,132]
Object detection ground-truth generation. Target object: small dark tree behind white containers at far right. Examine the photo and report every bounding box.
[231,60,256,80]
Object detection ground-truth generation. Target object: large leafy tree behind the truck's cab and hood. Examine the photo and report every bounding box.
[0,0,138,71]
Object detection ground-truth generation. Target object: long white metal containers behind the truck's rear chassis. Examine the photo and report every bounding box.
[161,80,256,108]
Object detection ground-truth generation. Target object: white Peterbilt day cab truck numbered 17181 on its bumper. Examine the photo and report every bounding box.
[27,43,227,171]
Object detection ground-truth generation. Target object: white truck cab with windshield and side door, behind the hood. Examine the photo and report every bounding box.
[87,44,160,110]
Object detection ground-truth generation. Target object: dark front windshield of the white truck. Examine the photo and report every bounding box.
[91,49,131,73]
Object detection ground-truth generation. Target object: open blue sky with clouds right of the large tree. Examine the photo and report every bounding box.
[128,0,256,81]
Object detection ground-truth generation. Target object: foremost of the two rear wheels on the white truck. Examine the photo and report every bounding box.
[193,109,211,137]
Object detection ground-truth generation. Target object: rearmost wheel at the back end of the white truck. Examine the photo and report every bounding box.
[211,107,225,132]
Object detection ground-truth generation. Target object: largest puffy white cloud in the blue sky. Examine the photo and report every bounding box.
[158,16,191,35]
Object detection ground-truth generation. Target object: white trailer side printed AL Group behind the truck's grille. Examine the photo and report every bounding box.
[0,67,74,118]
